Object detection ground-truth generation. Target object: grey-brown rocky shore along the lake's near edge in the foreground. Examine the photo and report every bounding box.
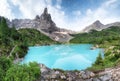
[38,64,120,81]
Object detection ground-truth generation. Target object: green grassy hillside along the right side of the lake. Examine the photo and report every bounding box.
[70,26,120,70]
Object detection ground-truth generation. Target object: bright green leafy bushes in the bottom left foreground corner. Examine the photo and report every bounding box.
[0,56,41,81]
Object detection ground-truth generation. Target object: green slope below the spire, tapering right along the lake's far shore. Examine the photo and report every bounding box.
[19,28,57,46]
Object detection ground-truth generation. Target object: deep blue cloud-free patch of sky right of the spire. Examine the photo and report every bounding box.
[58,0,102,14]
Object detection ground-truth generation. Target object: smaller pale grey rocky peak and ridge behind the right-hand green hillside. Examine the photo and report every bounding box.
[83,20,120,32]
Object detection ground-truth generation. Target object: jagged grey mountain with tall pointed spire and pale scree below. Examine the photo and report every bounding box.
[2,8,74,42]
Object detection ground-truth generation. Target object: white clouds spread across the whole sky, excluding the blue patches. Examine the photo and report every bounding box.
[0,0,120,31]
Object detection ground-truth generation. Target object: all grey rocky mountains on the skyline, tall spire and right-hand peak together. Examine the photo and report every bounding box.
[0,8,120,42]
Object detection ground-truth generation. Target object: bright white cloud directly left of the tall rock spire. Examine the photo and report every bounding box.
[11,0,47,19]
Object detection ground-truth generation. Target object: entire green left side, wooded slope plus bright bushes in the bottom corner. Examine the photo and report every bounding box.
[0,17,57,81]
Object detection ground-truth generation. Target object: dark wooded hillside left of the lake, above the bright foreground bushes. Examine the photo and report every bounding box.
[0,17,57,58]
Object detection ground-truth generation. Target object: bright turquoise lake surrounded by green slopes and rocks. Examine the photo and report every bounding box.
[22,44,103,70]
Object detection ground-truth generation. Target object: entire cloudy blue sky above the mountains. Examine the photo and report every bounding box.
[0,0,120,31]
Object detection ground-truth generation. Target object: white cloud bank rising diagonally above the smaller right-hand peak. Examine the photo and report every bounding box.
[65,0,120,31]
